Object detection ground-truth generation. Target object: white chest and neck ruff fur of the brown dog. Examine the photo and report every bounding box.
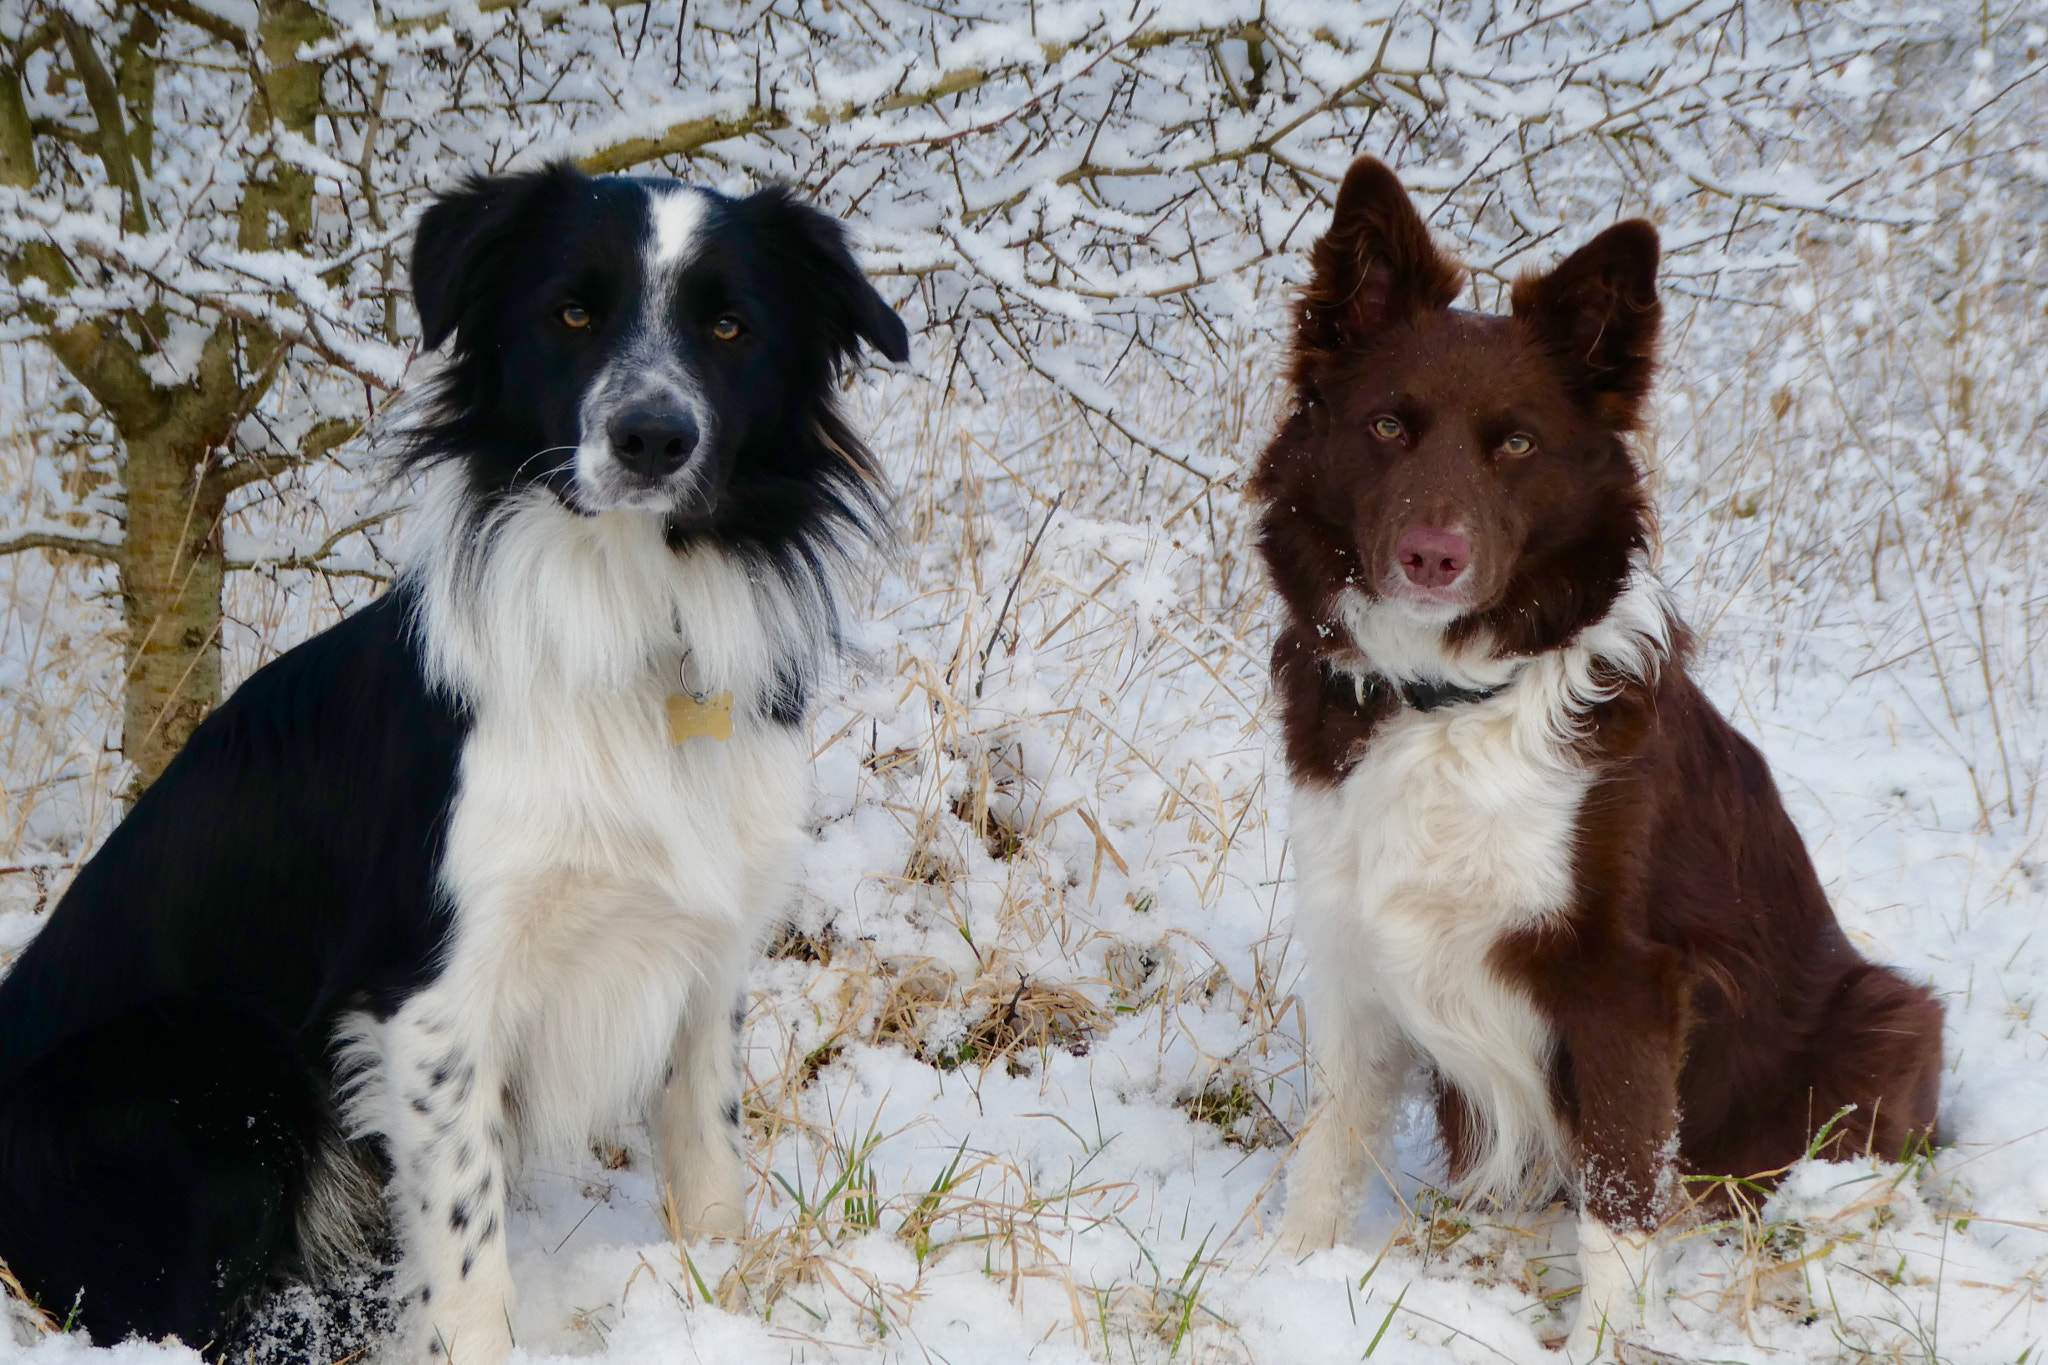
[1292,571,1669,1195]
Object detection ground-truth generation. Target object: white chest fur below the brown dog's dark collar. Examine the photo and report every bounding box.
[1294,688,1589,1193]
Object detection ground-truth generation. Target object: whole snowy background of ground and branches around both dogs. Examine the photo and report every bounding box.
[0,0,2048,1365]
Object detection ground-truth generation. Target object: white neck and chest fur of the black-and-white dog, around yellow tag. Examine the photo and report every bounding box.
[403,482,823,1150]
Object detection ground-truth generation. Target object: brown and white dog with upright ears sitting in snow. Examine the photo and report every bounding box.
[1251,158,1942,1359]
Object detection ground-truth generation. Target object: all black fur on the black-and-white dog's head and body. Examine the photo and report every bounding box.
[0,166,907,1347]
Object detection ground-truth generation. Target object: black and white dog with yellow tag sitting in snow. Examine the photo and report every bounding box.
[0,166,907,1365]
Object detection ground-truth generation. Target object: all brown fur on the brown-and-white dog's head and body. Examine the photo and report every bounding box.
[1251,158,1942,1228]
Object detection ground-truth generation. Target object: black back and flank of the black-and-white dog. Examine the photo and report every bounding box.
[0,591,465,1347]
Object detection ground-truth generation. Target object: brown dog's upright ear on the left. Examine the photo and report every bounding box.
[1296,156,1464,352]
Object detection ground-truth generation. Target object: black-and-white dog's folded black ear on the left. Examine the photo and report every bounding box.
[412,162,590,350]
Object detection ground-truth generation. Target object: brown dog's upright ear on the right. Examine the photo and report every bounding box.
[1513,219,1663,430]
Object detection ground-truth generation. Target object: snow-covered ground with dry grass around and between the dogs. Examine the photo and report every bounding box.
[0,192,2048,1365]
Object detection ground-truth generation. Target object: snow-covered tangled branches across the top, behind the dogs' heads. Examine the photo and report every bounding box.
[0,0,1997,501]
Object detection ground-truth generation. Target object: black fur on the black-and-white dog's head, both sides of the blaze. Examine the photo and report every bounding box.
[408,164,909,589]
